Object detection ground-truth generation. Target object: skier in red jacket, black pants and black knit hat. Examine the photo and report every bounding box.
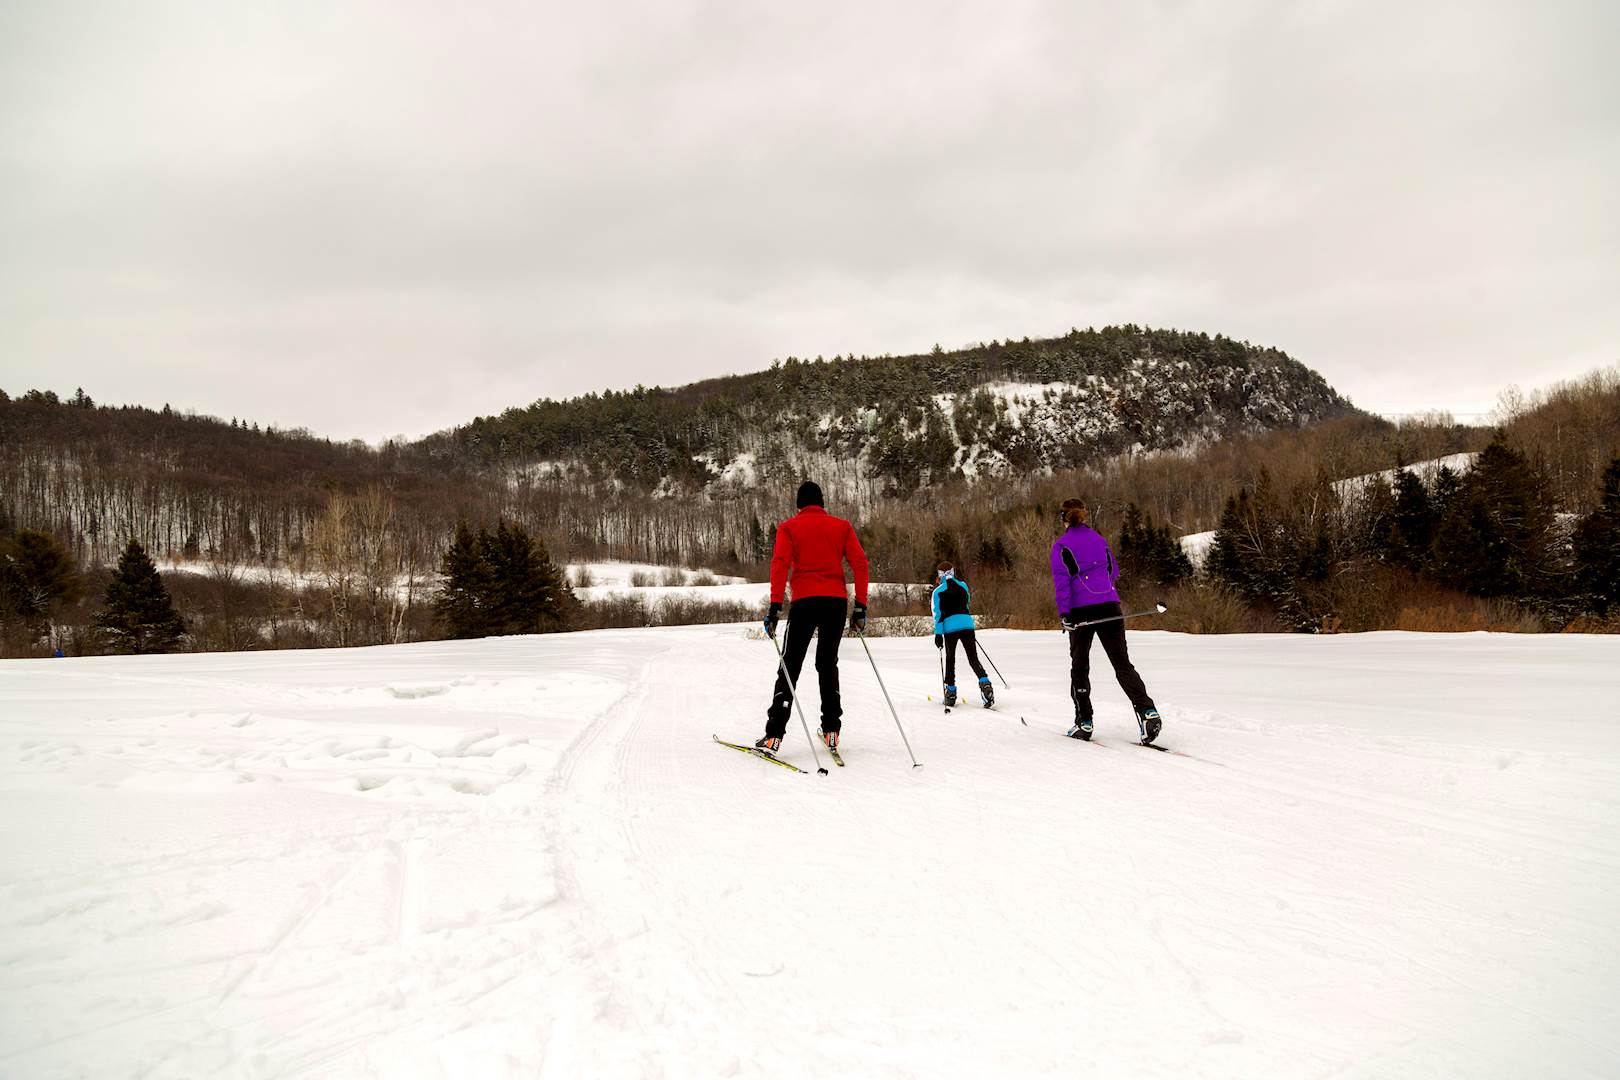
[753,479,868,753]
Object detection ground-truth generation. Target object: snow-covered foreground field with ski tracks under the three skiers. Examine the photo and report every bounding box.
[0,627,1620,1078]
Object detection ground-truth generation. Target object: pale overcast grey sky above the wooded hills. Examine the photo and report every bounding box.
[0,0,1620,440]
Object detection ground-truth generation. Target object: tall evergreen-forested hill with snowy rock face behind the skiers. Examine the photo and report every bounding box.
[423,325,1353,495]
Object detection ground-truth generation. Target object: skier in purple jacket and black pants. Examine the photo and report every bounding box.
[1051,499,1160,743]
